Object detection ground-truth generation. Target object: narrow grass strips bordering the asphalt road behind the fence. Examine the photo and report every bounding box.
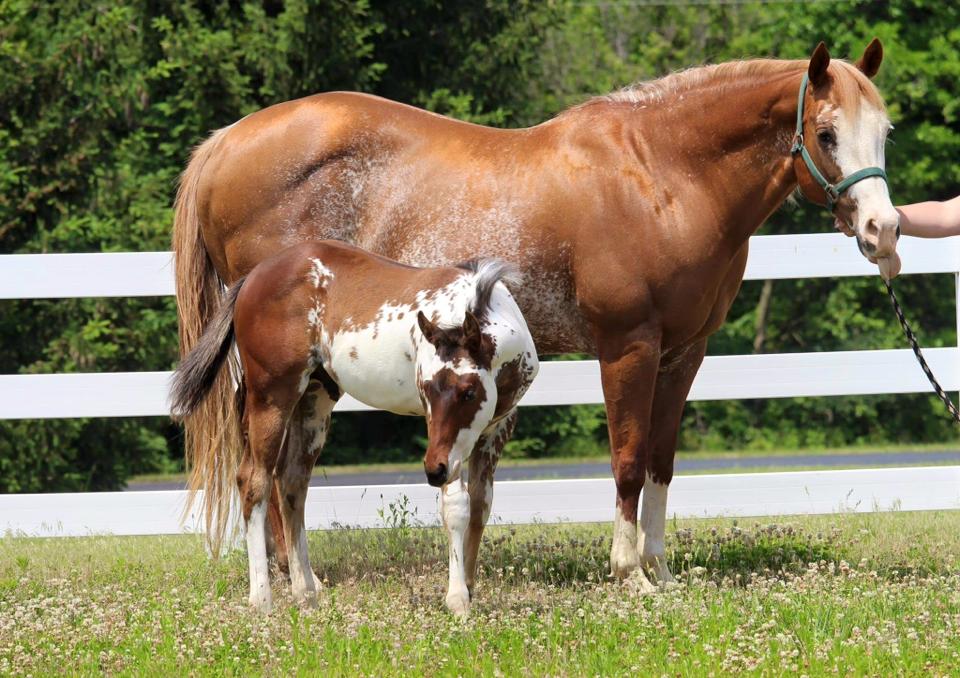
[130,443,956,486]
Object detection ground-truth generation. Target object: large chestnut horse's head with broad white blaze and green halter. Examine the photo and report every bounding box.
[794,39,900,278]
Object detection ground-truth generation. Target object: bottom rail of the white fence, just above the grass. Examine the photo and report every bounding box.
[0,466,960,537]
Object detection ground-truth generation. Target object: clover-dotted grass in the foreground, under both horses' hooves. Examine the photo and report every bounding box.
[0,512,960,676]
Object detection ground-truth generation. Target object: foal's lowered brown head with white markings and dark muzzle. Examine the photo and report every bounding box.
[417,311,497,487]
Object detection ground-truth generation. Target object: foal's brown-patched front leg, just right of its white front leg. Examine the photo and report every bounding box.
[464,408,517,598]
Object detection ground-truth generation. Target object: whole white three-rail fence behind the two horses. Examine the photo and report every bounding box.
[0,234,960,535]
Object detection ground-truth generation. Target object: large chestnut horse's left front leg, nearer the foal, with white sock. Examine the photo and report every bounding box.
[597,328,660,590]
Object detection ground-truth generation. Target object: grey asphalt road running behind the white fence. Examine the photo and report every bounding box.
[127,450,960,491]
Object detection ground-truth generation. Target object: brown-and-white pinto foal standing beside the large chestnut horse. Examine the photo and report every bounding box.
[173,241,538,614]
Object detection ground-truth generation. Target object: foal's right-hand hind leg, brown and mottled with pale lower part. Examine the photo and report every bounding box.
[277,380,336,606]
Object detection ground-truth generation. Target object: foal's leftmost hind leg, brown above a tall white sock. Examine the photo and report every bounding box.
[237,398,286,612]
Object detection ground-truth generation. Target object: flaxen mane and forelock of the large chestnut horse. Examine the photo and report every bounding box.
[568,59,883,111]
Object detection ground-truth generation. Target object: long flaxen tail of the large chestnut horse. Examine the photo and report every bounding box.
[173,128,243,554]
